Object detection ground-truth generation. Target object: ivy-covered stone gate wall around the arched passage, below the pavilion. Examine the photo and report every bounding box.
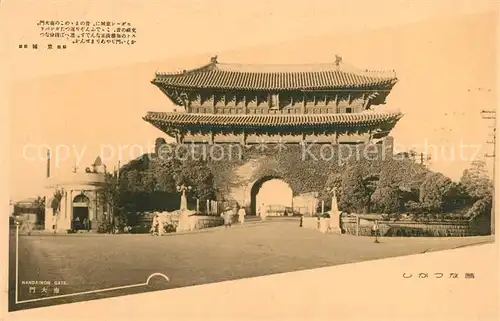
[204,141,393,215]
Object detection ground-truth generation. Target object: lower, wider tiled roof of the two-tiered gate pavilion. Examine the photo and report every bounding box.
[143,112,403,129]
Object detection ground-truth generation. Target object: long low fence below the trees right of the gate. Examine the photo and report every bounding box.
[341,217,489,237]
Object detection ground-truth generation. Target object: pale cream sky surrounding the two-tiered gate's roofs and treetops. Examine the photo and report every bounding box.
[0,0,497,199]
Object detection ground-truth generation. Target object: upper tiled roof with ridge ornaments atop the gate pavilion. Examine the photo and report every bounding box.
[152,59,397,90]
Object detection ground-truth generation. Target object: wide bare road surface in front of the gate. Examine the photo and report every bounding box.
[10,222,493,309]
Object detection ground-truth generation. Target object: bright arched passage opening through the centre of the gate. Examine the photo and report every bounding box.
[250,176,293,216]
